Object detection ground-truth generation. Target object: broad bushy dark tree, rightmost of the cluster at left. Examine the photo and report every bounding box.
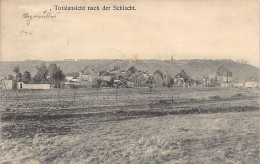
[48,63,65,84]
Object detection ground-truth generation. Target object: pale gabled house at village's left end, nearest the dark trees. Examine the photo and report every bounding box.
[79,66,98,81]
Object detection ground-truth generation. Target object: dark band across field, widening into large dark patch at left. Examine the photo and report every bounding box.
[1,104,259,139]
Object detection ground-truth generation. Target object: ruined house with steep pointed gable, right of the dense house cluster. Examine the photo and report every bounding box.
[173,70,193,87]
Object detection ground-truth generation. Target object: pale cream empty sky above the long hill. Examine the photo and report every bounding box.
[0,0,259,66]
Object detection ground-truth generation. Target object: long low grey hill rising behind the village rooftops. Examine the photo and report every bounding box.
[0,59,259,82]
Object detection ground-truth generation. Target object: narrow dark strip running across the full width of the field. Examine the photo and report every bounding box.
[1,104,259,122]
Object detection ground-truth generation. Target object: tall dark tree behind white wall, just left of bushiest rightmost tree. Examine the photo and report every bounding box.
[33,62,48,83]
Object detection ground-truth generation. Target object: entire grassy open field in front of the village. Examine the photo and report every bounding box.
[0,88,259,164]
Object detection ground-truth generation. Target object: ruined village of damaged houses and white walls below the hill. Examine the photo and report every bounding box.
[0,61,259,90]
